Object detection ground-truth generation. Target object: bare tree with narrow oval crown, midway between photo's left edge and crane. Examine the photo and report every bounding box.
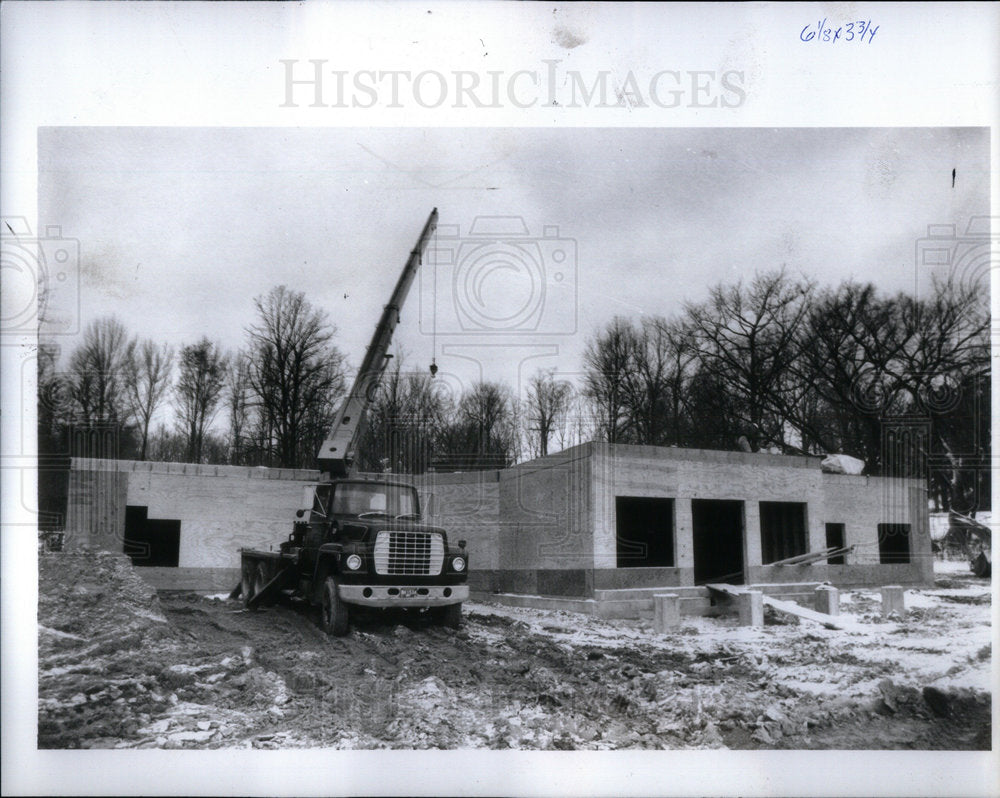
[174,338,226,463]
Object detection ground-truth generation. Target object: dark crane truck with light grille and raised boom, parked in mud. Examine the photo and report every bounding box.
[232,208,469,636]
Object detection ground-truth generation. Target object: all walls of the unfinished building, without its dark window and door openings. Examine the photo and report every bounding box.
[67,443,933,596]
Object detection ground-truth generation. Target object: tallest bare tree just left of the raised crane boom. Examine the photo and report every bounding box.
[247,285,344,467]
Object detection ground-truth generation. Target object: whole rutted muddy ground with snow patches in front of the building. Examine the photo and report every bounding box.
[38,553,991,750]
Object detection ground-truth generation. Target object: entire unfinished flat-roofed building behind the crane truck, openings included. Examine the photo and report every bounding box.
[66,443,933,617]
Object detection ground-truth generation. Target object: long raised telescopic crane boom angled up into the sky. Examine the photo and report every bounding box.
[318,208,437,479]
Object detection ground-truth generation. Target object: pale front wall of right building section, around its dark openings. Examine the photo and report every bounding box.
[591,443,933,588]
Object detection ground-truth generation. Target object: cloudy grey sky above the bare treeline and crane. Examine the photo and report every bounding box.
[38,127,990,416]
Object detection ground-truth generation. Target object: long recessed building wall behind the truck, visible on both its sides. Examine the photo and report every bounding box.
[66,458,499,587]
